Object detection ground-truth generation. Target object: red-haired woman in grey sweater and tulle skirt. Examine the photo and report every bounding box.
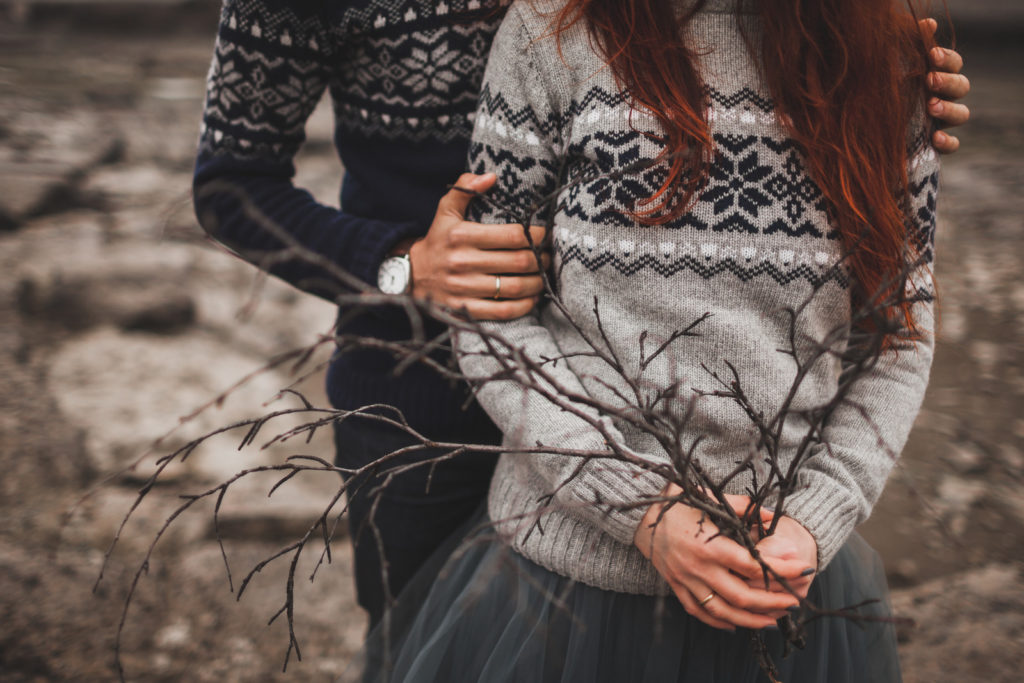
[366,0,938,682]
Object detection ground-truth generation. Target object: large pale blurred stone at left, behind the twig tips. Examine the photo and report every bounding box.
[48,327,294,476]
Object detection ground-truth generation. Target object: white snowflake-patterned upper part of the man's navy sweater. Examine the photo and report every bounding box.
[203,0,501,157]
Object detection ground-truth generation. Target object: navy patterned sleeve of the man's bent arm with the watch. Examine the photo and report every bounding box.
[193,0,423,299]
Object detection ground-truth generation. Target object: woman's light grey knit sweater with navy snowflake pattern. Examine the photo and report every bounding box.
[458,0,938,594]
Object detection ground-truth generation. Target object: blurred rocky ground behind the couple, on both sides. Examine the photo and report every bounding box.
[0,0,1024,683]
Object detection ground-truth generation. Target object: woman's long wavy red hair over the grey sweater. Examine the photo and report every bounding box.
[553,0,932,329]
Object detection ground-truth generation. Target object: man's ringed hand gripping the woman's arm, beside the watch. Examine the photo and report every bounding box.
[409,173,550,321]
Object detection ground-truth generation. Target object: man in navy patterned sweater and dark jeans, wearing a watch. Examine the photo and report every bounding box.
[195,0,969,624]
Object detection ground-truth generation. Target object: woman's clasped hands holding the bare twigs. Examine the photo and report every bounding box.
[633,484,813,631]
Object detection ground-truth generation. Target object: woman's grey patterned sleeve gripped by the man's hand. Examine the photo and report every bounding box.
[456,3,665,545]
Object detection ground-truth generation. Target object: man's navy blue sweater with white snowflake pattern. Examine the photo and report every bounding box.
[194,0,502,437]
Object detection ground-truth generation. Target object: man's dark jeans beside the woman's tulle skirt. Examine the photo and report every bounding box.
[334,418,500,628]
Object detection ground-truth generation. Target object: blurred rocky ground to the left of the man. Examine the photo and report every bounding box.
[0,3,365,681]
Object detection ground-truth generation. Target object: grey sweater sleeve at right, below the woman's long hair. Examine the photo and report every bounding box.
[784,142,939,567]
